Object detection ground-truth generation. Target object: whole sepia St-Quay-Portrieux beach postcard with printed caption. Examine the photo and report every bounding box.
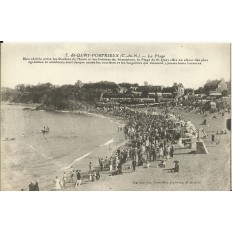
[0,43,231,191]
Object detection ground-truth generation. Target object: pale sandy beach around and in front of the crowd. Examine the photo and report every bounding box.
[50,110,230,191]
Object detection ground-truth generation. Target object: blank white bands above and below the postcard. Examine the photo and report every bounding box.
[0,0,232,232]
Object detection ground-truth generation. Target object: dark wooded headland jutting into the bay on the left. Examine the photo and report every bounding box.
[1,80,138,110]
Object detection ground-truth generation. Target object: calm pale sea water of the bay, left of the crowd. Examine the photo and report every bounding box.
[1,104,123,190]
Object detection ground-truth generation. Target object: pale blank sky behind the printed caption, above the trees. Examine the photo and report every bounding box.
[1,43,230,89]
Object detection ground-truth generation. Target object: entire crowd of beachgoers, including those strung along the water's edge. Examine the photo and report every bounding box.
[26,103,229,191]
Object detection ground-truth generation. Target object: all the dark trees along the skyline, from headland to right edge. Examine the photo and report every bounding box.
[1,80,230,110]
